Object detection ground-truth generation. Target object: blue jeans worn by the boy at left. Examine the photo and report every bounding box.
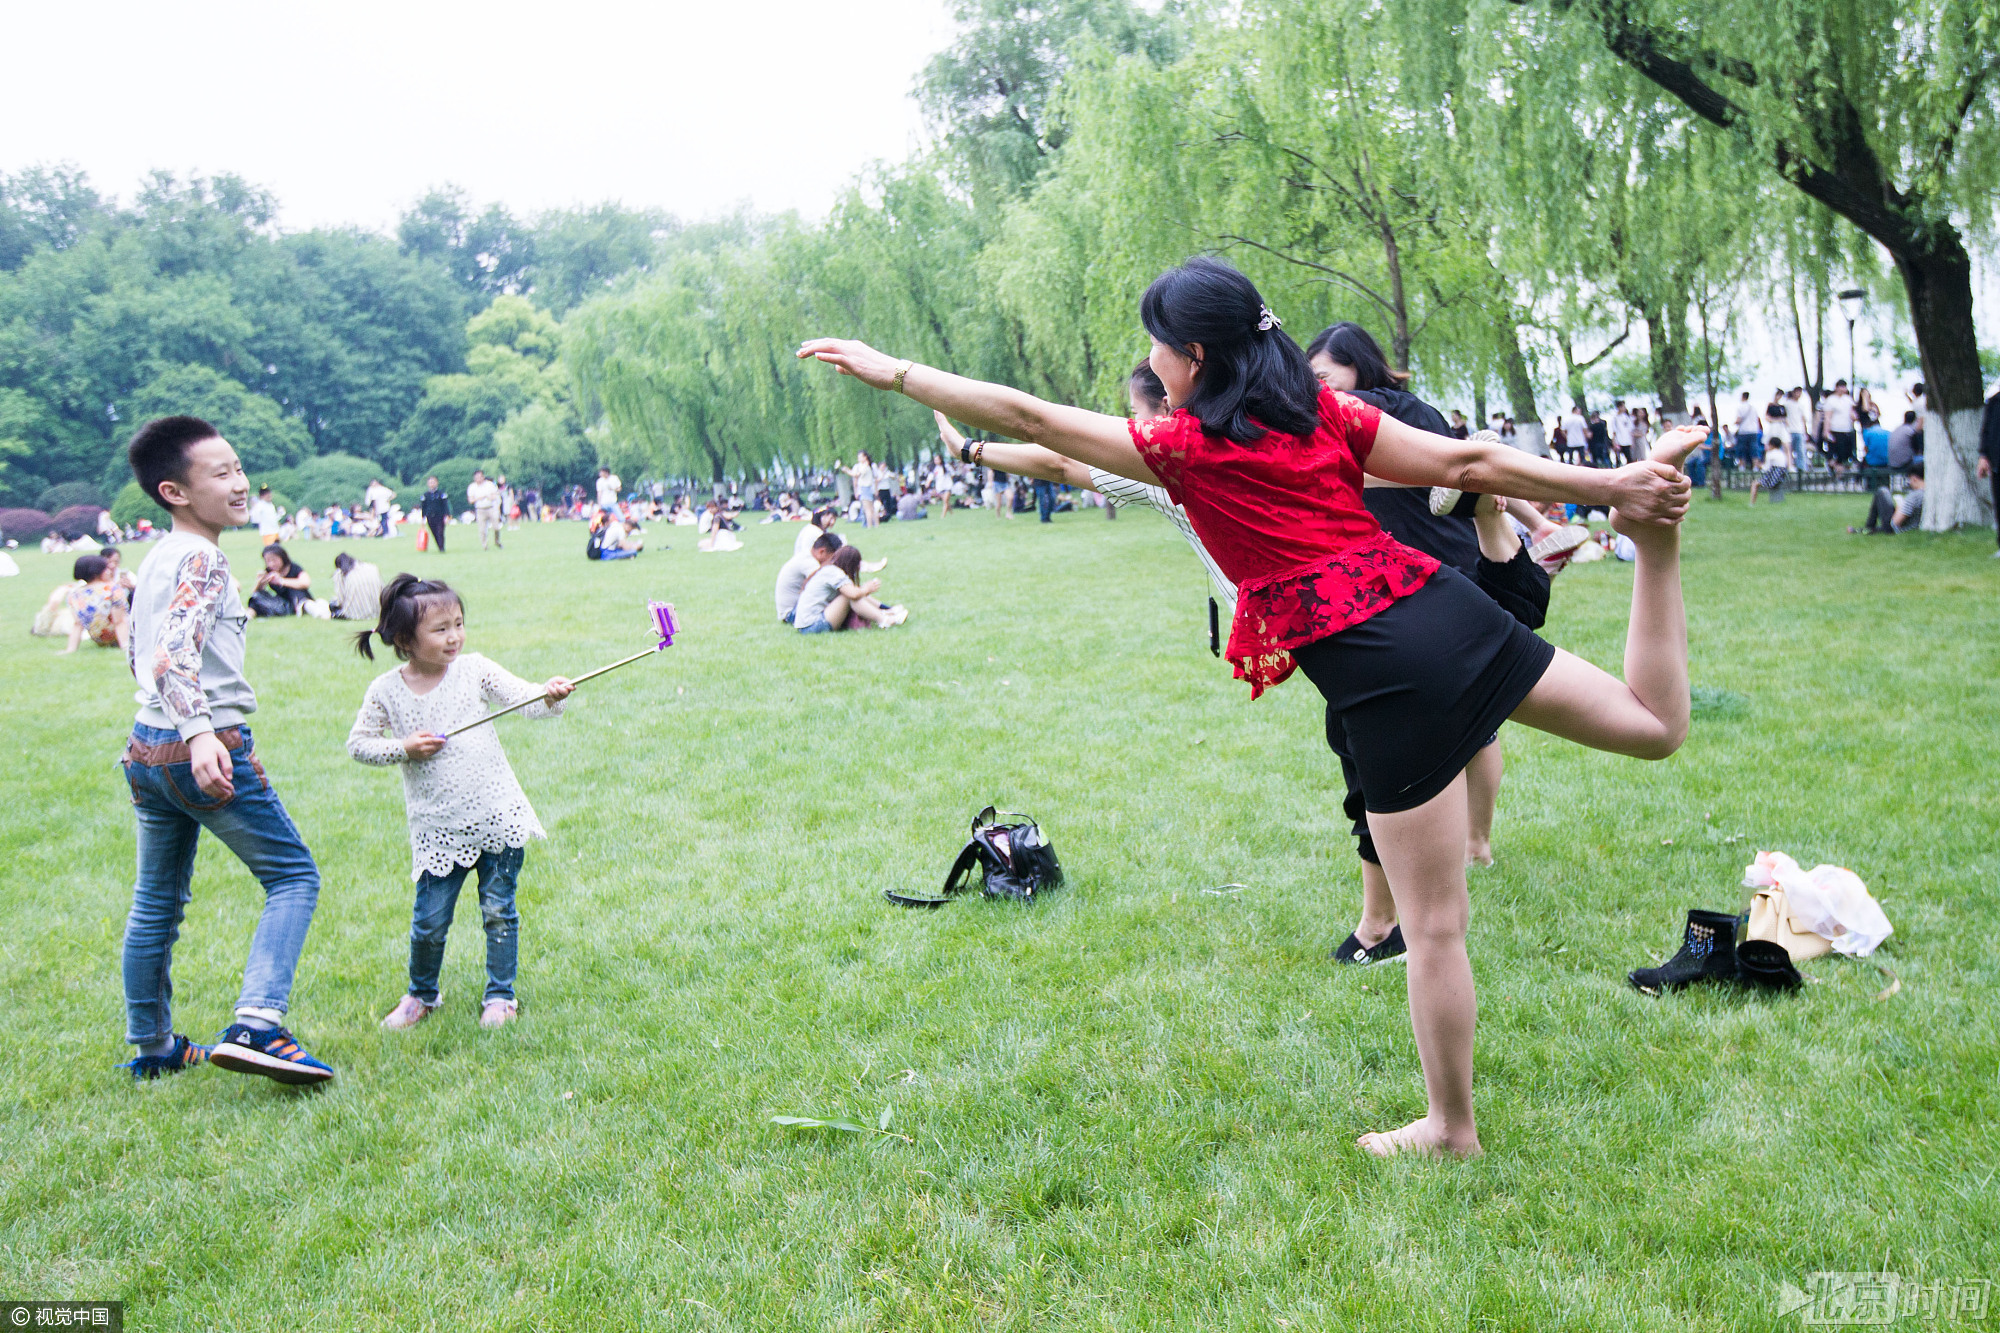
[124,725,320,1045]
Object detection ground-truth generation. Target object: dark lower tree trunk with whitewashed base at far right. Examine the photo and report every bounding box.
[1896,241,1994,532]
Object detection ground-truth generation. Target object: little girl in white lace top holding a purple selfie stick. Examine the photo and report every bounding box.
[348,574,574,1029]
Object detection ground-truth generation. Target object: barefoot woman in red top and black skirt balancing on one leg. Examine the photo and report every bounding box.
[798,258,1704,1155]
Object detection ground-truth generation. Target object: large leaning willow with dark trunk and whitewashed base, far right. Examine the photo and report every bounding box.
[1504,0,2000,528]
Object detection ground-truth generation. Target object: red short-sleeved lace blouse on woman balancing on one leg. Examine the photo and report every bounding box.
[1132,388,1438,699]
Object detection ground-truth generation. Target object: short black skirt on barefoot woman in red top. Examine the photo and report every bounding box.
[1292,564,1556,815]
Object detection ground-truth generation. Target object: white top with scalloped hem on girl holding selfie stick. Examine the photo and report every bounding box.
[348,652,562,881]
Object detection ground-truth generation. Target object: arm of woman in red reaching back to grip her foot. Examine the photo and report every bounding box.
[1368,414,1708,522]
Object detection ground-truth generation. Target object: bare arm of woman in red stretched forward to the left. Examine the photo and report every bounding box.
[798,338,1160,486]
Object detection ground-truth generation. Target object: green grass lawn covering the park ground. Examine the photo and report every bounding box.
[0,496,2000,1331]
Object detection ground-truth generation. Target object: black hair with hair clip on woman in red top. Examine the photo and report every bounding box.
[1138,256,1320,444]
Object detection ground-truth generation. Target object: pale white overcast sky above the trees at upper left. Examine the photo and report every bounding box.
[0,0,950,228]
